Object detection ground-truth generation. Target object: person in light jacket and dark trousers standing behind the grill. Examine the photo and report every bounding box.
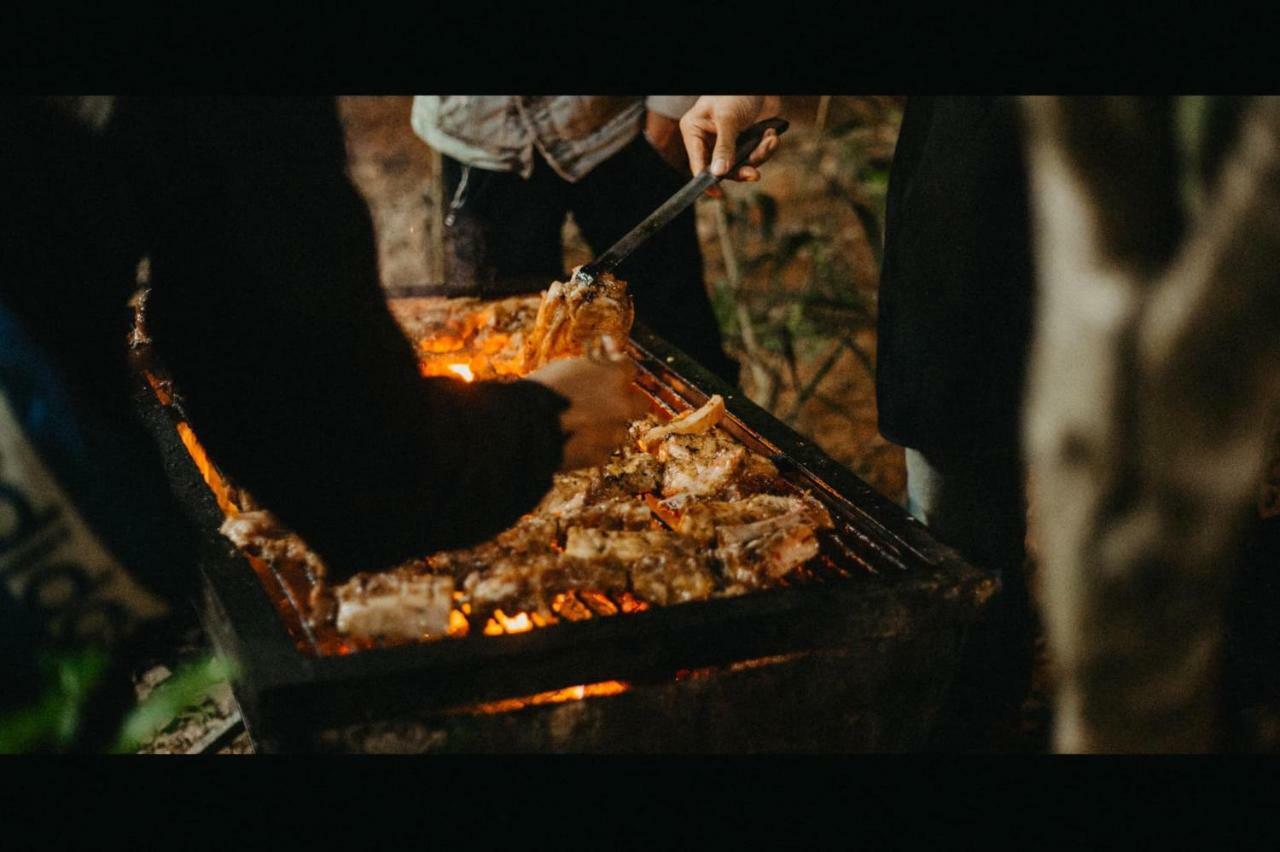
[412,95,739,384]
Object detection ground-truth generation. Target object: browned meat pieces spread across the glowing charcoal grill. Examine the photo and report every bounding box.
[213,295,831,641]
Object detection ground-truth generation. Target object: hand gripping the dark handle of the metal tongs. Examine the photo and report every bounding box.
[680,95,781,194]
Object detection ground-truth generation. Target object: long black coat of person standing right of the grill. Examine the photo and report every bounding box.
[876,96,1036,455]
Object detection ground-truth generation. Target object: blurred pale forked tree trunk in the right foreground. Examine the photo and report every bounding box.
[1027,97,1280,752]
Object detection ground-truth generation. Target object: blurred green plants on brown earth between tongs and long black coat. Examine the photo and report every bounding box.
[699,96,905,499]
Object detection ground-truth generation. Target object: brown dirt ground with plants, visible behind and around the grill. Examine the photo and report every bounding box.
[129,96,1046,753]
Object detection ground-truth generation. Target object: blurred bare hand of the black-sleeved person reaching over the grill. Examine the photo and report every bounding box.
[525,358,649,471]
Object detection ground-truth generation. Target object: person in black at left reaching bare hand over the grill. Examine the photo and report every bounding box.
[0,97,643,750]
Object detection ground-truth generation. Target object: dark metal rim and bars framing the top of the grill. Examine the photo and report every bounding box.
[137,313,998,751]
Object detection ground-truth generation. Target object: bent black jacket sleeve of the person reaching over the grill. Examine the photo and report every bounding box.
[113,99,567,578]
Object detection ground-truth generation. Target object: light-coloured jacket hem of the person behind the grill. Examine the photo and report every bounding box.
[411,95,698,182]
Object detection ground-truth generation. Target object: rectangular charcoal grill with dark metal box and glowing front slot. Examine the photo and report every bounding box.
[138,303,997,751]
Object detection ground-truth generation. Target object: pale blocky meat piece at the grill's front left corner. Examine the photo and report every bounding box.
[334,568,453,640]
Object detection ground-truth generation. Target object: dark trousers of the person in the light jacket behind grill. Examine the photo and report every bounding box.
[443,134,739,384]
